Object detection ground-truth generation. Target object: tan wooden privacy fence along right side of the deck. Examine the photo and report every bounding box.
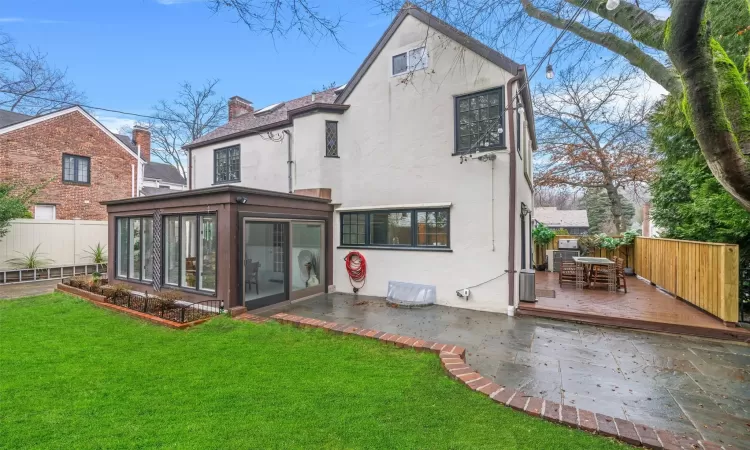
[634,237,740,323]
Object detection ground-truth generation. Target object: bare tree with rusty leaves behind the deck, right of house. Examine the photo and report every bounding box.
[535,68,656,233]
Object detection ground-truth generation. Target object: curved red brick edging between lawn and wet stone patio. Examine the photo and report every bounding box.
[268,313,724,450]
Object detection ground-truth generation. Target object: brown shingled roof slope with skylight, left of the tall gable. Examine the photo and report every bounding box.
[185,88,349,148]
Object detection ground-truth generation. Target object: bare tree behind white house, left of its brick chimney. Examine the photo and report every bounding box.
[148,79,227,179]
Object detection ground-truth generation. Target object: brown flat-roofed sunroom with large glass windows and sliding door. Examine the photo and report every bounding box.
[103,186,333,309]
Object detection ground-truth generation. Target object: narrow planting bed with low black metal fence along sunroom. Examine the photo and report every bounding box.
[63,278,224,323]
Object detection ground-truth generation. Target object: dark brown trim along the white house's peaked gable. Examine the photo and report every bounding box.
[336,2,525,104]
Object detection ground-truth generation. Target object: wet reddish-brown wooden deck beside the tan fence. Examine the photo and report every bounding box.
[518,272,750,342]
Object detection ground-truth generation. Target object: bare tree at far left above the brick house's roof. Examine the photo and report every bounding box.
[0,34,85,115]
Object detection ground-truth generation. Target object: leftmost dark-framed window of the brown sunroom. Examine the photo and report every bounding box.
[115,217,154,281]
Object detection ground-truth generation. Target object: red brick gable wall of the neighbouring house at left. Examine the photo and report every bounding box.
[0,111,136,220]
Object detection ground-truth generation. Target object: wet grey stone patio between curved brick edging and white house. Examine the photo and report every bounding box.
[261,294,750,449]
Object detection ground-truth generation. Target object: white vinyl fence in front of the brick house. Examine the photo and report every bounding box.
[0,219,110,271]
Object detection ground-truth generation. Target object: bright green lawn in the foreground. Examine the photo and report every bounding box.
[0,294,620,449]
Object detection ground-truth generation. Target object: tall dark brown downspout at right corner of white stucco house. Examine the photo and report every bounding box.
[505,66,526,316]
